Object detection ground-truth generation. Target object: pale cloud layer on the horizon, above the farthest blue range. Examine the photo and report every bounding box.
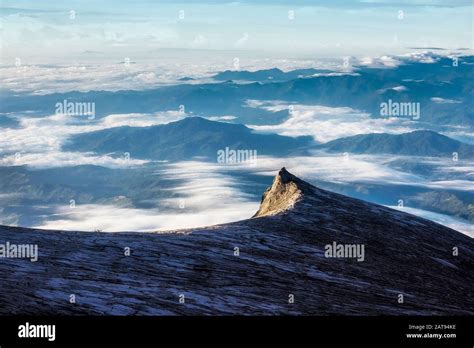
[0,58,340,94]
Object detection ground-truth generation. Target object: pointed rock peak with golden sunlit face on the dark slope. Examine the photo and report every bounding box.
[253,167,312,217]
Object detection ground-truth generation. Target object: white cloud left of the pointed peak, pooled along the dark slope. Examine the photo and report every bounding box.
[36,162,259,232]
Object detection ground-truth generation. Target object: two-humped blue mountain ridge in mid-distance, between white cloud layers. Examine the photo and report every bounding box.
[64,117,474,161]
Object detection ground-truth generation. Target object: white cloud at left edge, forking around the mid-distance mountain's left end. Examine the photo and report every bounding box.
[0,111,186,168]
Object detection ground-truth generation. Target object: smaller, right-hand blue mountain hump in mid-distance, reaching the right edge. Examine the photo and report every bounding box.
[318,130,474,160]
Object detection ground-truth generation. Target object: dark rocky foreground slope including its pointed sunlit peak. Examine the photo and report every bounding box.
[0,168,474,315]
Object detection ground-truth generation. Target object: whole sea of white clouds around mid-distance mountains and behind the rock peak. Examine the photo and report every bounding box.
[0,101,474,235]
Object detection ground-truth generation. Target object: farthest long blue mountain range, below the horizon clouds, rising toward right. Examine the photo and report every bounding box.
[0,56,474,127]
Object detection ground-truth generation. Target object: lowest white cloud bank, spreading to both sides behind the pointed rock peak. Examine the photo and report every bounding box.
[11,153,474,231]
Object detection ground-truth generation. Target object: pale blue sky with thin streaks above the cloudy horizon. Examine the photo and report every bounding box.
[0,0,473,64]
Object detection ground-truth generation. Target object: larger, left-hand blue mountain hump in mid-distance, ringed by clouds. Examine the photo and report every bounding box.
[64,117,313,161]
